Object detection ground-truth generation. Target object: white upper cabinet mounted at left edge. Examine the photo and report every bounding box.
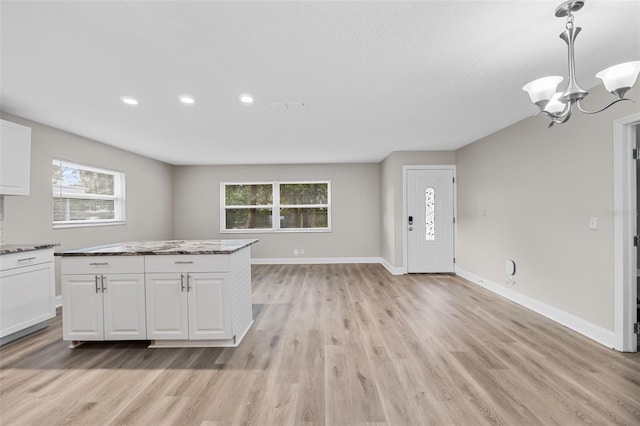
[0,120,31,195]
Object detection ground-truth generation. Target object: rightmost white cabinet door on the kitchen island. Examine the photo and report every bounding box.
[188,273,231,340]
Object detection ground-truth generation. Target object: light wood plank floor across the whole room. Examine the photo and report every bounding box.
[0,265,640,425]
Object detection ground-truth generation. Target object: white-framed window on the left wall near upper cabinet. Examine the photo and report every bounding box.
[52,160,125,228]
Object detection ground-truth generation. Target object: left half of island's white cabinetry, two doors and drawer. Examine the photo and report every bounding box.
[62,256,147,341]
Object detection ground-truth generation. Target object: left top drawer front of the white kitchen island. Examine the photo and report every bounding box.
[61,256,144,275]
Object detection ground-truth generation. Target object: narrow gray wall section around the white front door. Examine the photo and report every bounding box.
[380,151,456,268]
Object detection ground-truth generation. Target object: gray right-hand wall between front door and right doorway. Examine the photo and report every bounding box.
[456,83,640,330]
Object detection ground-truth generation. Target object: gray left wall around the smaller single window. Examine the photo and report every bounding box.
[0,113,173,294]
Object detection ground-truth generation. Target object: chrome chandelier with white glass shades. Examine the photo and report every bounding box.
[522,1,640,127]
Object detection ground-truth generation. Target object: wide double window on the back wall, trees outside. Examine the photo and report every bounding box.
[220,181,331,232]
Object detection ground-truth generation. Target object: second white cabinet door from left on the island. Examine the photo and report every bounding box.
[101,274,147,340]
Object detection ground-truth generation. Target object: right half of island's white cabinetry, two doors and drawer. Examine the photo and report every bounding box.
[145,255,232,340]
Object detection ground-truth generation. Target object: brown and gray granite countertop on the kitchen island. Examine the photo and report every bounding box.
[55,240,258,256]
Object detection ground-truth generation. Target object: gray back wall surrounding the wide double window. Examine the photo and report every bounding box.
[173,163,380,258]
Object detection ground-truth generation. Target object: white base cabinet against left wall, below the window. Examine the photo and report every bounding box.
[0,249,56,343]
